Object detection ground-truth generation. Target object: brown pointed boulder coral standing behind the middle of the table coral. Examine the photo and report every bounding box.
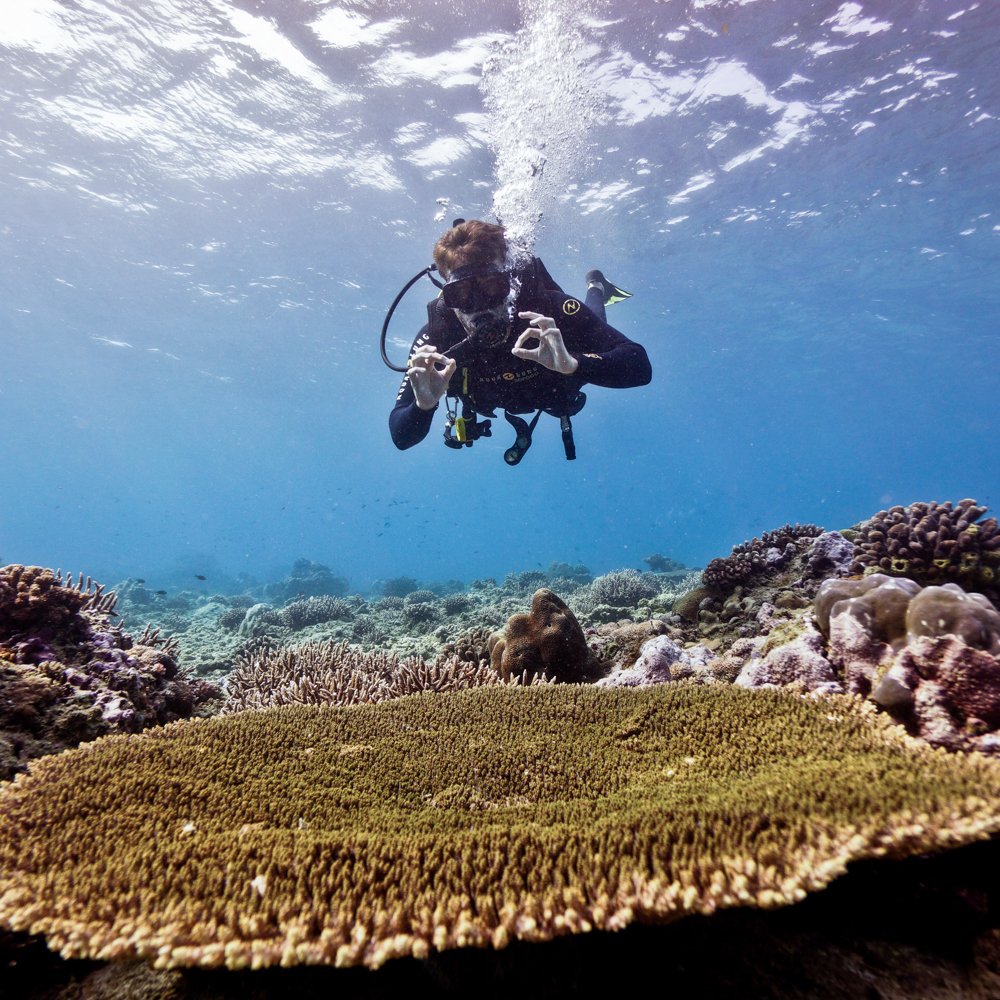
[490,587,600,682]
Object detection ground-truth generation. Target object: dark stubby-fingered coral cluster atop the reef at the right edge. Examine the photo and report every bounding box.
[852,500,1000,589]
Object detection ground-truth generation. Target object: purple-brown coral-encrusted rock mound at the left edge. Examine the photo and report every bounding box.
[0,565,221,780]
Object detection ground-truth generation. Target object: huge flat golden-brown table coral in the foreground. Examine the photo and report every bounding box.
[0,686,1000,968]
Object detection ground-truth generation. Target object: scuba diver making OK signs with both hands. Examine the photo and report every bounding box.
[382,219,652,465]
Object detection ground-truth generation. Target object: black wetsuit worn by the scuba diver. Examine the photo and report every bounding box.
[389,261,653,449]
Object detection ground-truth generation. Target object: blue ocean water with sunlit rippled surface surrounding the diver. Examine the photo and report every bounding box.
[0,0,1000,590]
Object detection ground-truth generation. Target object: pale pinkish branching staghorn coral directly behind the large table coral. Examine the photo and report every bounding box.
[223,640,542,714]
